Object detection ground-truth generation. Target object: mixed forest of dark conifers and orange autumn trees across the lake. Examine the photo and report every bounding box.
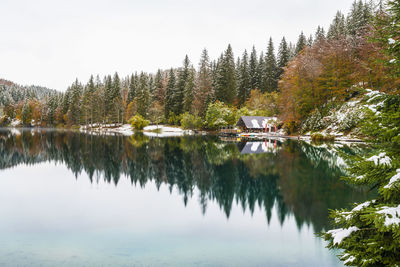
[0,0,400,133]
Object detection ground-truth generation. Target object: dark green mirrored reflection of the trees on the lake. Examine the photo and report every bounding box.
[0,130,366,232]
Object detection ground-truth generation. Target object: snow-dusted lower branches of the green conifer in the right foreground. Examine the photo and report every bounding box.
[322,95,400,266]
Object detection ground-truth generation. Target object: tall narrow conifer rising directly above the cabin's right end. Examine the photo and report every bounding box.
[264,38,278,92]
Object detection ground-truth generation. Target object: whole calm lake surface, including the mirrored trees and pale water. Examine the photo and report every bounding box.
[0,129,369,266]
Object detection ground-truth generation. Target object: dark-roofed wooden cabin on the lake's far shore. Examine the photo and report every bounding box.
[236,116,277,133]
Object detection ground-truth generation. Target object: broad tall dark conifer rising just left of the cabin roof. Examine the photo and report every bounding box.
[215,45,237,104]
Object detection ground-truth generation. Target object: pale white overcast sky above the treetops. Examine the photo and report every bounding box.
[0,0,352,91]
